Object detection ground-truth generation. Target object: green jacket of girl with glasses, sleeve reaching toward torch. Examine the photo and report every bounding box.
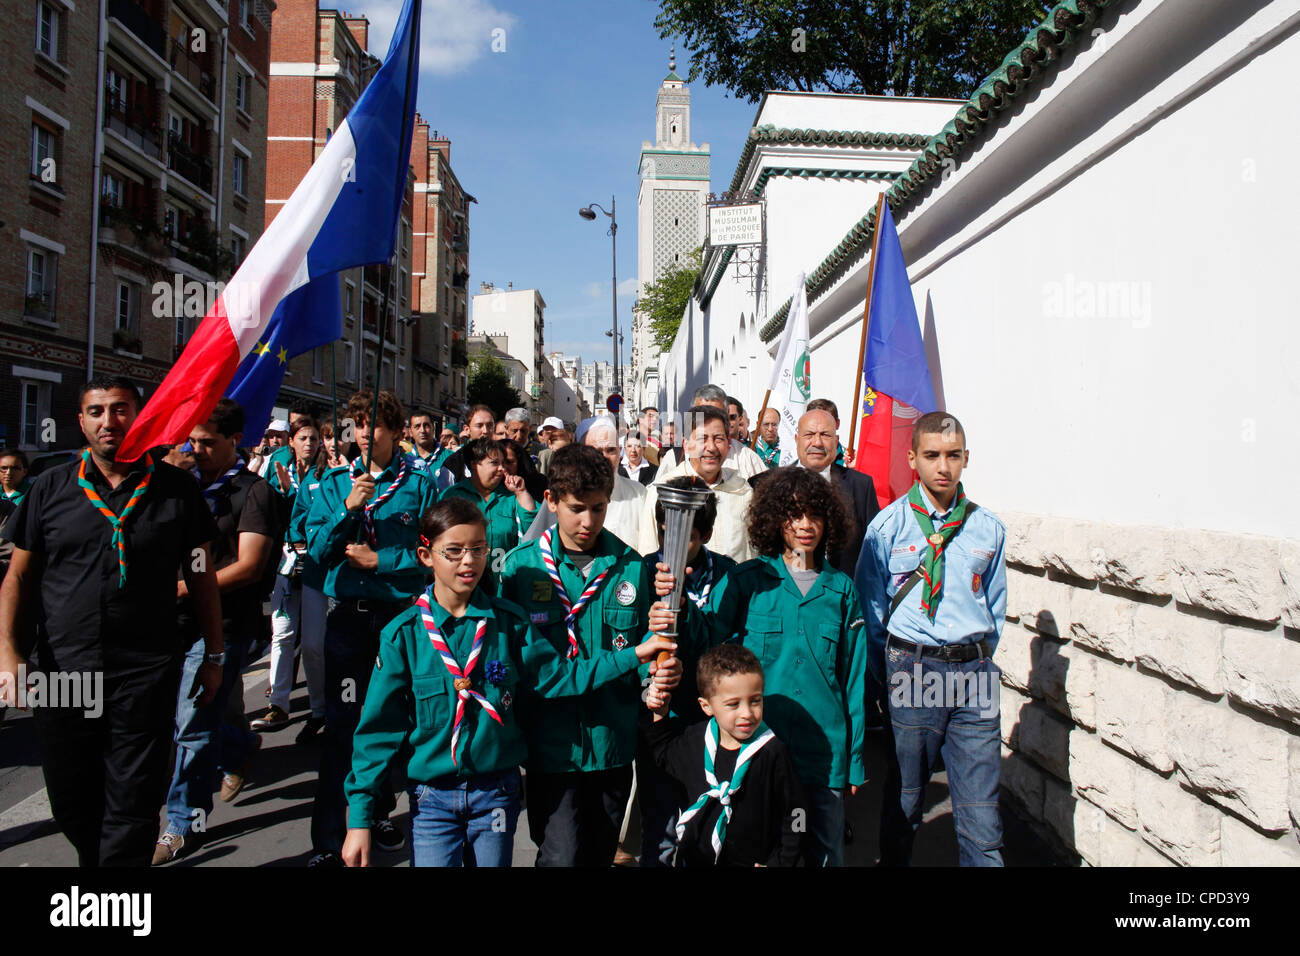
[345,588,637,827]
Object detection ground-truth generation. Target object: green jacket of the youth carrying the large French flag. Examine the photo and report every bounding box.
[307,451,438,601]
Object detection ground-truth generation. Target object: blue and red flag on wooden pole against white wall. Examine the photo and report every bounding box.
[853,202,939,507]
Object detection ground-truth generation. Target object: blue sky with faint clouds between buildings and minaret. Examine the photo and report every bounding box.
[361,0,757,362]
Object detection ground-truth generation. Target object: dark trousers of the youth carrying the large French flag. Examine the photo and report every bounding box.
[312,598,400,853]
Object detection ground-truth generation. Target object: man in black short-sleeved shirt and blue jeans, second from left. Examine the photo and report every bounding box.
[153,398,278,865]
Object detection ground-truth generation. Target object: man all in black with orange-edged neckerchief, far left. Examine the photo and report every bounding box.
[0,378,221,866]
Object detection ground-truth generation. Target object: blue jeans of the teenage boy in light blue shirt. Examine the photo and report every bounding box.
[880,646,1002,866]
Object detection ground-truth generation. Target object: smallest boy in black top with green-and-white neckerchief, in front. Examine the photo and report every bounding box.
[646,644,807,866]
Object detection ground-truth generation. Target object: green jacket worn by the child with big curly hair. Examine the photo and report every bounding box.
[680,555,867,787]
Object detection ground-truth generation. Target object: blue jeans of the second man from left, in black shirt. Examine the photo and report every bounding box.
[166,636,250,834]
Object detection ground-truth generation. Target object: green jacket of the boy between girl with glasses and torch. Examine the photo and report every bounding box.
[501,529,654,774]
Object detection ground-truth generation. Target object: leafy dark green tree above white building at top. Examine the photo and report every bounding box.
[654,0,1052,103]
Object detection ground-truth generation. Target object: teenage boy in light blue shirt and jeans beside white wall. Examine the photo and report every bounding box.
[857,412,1006,866]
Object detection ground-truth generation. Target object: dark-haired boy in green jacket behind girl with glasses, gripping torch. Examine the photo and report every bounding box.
[501,445,681,866]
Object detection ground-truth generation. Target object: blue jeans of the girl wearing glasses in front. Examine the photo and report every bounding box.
[410,770,520,866]
